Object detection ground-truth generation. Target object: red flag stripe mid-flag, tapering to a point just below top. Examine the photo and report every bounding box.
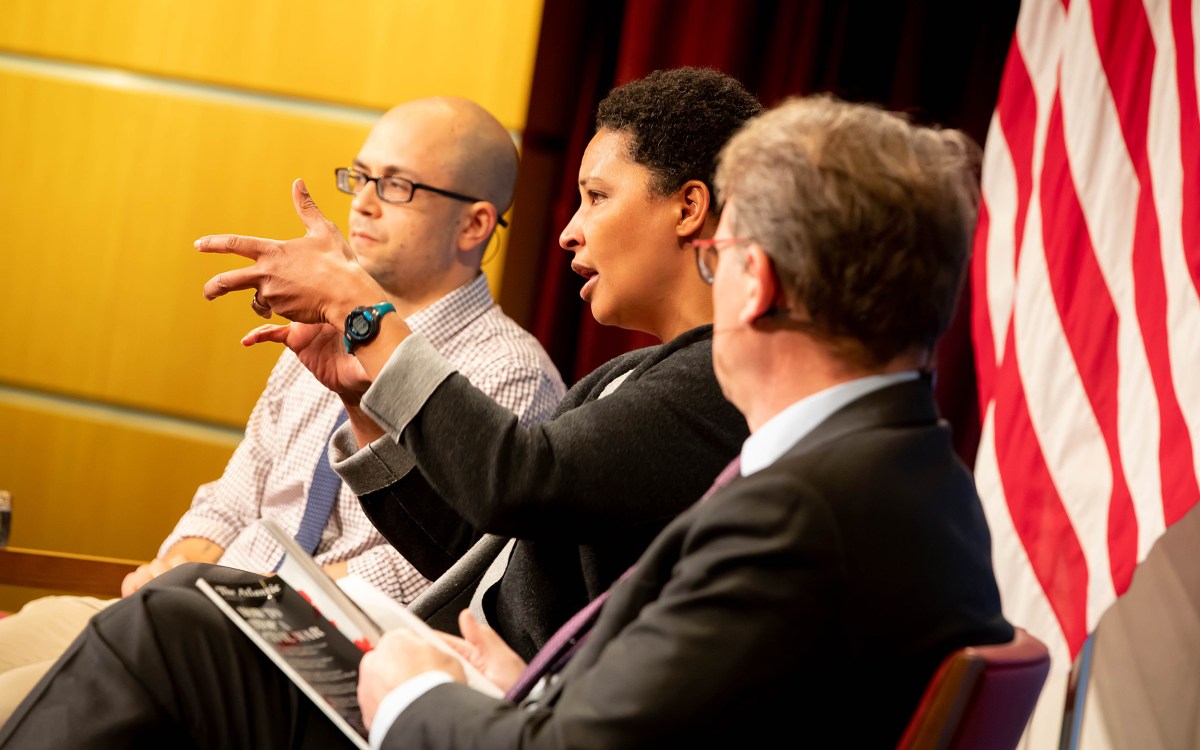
[1040,87,1138,590]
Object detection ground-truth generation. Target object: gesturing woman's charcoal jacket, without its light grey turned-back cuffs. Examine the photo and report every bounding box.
[361,325,749,659]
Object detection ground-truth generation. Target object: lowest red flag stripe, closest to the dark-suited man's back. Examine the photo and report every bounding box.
[992,324,1088,658]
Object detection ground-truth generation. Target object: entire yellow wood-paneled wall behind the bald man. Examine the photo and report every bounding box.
[0,0,541,608]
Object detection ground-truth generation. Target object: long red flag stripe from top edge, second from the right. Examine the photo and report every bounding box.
[1093,2,1200,530]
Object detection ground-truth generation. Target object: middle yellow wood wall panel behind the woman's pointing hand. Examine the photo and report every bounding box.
[0,70,516,428]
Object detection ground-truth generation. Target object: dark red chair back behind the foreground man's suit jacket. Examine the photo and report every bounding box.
[898,628,1050,750]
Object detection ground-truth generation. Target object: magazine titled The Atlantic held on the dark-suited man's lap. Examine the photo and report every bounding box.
[196,518,504,749]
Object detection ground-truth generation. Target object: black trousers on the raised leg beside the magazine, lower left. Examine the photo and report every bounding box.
[0,564,354,750]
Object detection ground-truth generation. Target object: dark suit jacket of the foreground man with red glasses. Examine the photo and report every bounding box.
[385,378,1013,750]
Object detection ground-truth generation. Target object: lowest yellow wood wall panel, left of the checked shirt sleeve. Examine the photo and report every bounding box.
[0,392,239,559]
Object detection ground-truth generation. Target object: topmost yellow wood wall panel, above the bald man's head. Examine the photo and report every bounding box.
[0,0,542,131]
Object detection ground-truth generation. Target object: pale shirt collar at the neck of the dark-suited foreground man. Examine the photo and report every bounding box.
[742,371,919,476]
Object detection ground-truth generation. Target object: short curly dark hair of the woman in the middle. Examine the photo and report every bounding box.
[596,67,763,196]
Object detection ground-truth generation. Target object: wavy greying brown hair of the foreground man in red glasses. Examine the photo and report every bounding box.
[716,95,979,366]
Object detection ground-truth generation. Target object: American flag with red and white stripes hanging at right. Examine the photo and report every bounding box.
[971,0,1200,748]
